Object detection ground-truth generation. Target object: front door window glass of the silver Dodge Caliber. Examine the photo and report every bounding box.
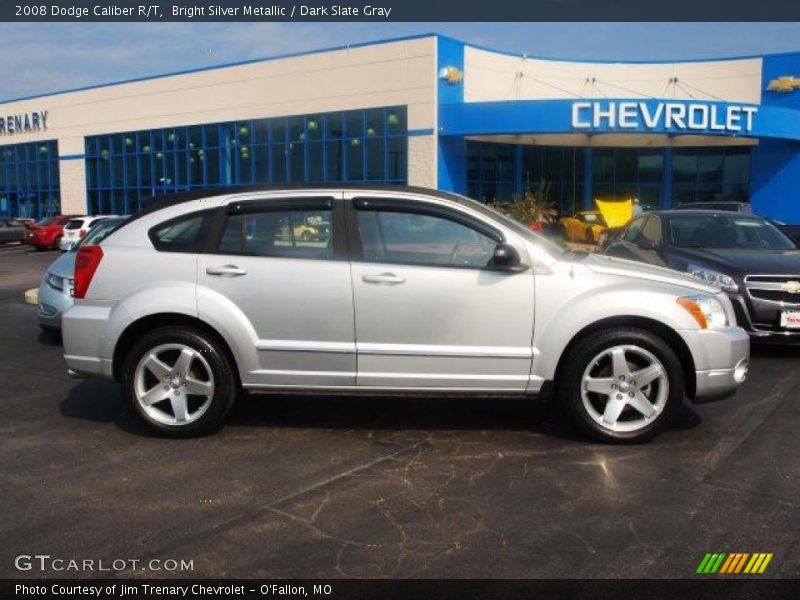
[358,210,497,267]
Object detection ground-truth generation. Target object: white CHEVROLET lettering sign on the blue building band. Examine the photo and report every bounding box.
[572,100,758,134]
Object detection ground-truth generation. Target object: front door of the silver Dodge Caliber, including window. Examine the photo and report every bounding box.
[345,194,534,391]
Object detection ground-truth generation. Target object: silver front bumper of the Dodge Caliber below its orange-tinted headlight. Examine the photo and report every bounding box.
[680,327,750,402]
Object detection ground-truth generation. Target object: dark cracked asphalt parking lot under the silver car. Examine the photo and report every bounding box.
[0,246,800,578]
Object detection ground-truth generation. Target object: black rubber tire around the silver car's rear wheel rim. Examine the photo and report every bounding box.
[120,326,240,438]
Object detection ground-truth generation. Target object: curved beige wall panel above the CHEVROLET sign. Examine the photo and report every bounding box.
[464,46,762,104]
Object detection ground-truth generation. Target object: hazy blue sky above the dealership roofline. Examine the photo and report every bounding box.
[0,23,800,101]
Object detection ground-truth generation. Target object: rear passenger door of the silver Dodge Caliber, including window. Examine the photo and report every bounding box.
[197,194,356,386]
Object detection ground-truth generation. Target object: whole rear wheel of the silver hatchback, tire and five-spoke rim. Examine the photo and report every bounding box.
[121,327,238,437]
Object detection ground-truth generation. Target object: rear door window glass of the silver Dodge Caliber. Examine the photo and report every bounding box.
[218,209,333,259]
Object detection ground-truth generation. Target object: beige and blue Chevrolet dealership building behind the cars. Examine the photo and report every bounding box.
[0,34,800,223]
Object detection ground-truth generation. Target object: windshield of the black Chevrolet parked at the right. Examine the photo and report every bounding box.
[669,214,797,250]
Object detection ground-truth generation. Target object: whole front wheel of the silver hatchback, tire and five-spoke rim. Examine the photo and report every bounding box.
[558,328,684,443]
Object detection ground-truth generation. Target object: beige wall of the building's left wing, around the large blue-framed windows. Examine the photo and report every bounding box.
[0,37,436,212]
